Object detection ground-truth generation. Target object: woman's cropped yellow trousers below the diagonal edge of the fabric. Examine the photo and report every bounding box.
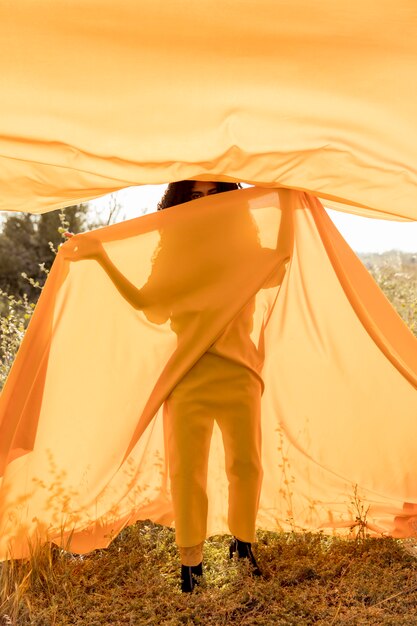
[164,352,263,565]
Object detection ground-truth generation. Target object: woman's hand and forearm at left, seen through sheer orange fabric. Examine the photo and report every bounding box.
[64,233,143,309]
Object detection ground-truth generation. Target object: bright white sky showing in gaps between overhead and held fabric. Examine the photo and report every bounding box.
[90,185,417,253]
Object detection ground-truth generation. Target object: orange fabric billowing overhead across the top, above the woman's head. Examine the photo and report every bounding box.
[0,0,417,219]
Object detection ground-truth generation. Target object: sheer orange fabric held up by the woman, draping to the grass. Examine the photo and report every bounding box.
[0,188,417,558]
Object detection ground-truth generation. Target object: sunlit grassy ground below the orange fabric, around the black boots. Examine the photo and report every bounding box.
[0,521,417,626]
